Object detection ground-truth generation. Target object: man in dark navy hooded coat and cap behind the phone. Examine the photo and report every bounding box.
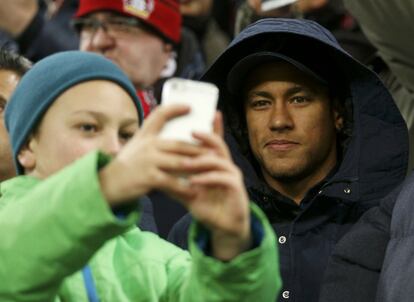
[170,19,408,302]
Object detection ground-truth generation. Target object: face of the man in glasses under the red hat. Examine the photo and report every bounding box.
[80,12,172,89]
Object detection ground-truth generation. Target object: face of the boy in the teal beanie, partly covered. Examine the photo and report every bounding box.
[18,80,138,178]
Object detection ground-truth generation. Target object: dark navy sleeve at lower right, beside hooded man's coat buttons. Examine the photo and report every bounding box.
[319,188,400,302]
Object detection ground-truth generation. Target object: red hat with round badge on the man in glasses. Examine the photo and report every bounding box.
[75,0,182,44]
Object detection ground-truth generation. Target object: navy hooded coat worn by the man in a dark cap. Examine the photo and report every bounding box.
[169,19,408,302]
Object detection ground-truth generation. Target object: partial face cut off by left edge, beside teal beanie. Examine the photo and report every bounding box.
[0,70,20,181]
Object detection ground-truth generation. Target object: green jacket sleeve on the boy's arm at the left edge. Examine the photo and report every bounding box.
[0,152,138,301]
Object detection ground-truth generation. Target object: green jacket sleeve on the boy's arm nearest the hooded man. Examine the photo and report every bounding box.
[162,204,281,302]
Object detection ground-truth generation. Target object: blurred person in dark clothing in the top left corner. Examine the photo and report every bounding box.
[0,0,79,62]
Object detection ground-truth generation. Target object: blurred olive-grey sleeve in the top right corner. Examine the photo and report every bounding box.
[345,0,414,92]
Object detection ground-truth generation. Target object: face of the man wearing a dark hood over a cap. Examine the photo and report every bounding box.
[245,62,342,183]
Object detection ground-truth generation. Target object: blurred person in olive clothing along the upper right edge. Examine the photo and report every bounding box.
[344,0,414,172]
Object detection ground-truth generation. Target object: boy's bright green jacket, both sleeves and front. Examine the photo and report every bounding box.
[0,152,281,302]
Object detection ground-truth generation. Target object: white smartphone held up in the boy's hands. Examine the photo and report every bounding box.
[160,78,219,143]
